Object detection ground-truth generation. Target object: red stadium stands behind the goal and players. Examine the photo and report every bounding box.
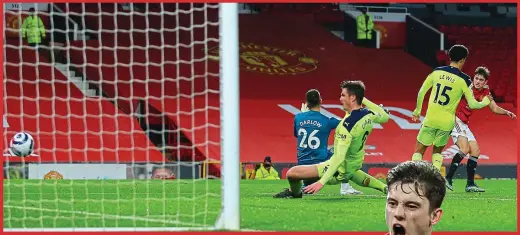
[4,4,517,179]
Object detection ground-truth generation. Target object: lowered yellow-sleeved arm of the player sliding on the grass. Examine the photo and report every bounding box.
[319,125,352,185]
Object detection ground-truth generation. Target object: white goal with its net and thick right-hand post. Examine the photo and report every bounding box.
[3,3,240,231]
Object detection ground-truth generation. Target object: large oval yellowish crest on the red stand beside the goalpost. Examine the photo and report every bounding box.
[208,43,318,75]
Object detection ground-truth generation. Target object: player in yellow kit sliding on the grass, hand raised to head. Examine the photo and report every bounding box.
[273,81,389,198]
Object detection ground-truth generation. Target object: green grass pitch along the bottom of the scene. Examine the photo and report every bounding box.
[4,180,517,231]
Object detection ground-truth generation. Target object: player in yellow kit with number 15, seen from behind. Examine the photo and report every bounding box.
[412,45,491,170]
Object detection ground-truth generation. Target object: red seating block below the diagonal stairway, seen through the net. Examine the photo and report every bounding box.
[4,41,164,163]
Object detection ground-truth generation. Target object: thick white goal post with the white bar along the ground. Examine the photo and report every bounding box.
[3,3,240,232]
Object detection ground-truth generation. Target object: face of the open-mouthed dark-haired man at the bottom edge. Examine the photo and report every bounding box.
[386,183,442,235]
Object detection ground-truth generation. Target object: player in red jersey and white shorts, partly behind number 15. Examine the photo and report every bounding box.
[446,67,516,192]
